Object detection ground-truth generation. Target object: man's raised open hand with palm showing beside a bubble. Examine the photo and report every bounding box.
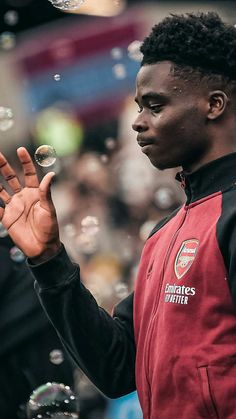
[0,147,60,261]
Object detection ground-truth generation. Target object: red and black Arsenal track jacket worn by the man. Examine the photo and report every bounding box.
[31,153,236,419]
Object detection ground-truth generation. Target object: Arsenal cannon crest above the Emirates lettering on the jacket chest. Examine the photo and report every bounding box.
[174,239,199,279]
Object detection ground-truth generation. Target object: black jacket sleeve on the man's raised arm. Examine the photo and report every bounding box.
[28,247,136,398]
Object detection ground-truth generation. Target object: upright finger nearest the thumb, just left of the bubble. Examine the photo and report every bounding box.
[17,147,39,188]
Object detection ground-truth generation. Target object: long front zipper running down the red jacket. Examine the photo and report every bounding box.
[144,209,189,406]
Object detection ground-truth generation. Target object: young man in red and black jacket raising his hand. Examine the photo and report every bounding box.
[0,13,236,419]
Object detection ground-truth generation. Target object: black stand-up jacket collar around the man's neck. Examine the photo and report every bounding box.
[176,153,236,204]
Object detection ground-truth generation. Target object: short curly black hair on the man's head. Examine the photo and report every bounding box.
[140,12,236,87]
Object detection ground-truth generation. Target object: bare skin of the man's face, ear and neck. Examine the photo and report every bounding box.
[133,61,236,172]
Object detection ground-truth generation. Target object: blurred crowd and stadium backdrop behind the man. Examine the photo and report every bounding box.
[0,0,236,419]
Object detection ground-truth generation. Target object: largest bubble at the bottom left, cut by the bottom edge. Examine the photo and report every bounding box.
[27,383,79,419]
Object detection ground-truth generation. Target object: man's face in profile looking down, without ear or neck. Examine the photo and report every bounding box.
[133,61,211,170]
